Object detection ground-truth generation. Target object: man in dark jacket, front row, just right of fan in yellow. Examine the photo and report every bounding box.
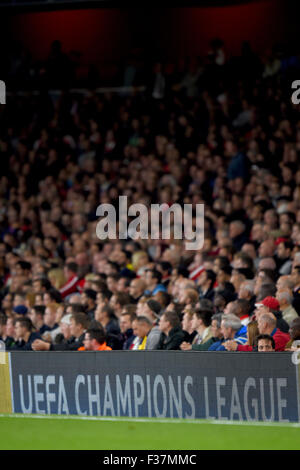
[157,311,185,350]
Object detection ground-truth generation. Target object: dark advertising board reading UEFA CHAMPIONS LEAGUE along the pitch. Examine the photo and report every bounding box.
[0,351,299,422]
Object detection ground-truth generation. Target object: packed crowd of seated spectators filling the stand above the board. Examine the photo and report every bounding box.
[0,41,300,351]
